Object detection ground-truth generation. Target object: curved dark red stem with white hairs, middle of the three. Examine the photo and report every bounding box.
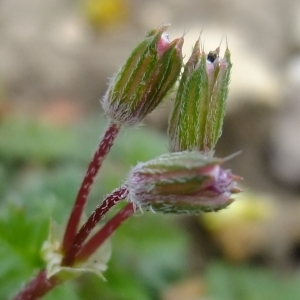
[62,187,128,266]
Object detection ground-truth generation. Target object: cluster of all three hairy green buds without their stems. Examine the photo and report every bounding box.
[102,26,240,213]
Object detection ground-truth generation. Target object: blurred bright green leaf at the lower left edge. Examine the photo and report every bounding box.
[0,200,47,299]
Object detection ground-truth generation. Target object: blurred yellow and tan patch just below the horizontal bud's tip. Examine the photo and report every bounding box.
[202,193,278,262]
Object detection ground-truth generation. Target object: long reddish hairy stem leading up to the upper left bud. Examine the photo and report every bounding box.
[63,123,120,251]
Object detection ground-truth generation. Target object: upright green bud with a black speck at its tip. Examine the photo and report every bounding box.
[168,41,232,154]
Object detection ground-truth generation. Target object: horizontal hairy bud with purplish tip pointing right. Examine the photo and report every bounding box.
[127,151,241,214]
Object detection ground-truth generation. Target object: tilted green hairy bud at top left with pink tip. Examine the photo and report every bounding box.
[102,26,183,125]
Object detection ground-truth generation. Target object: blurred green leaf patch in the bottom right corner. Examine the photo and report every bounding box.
[206,261,300,300]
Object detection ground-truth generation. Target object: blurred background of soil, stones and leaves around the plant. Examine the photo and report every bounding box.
[0,0,300,300]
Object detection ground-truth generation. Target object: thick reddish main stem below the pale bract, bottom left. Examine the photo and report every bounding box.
[14,270,61,300]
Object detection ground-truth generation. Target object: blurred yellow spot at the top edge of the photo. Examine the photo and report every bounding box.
[84,0,128,29]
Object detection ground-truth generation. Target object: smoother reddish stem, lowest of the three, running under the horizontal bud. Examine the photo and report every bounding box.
[77,203,134,261]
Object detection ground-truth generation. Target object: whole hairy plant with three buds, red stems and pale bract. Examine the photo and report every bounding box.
[14,26,241,300]
